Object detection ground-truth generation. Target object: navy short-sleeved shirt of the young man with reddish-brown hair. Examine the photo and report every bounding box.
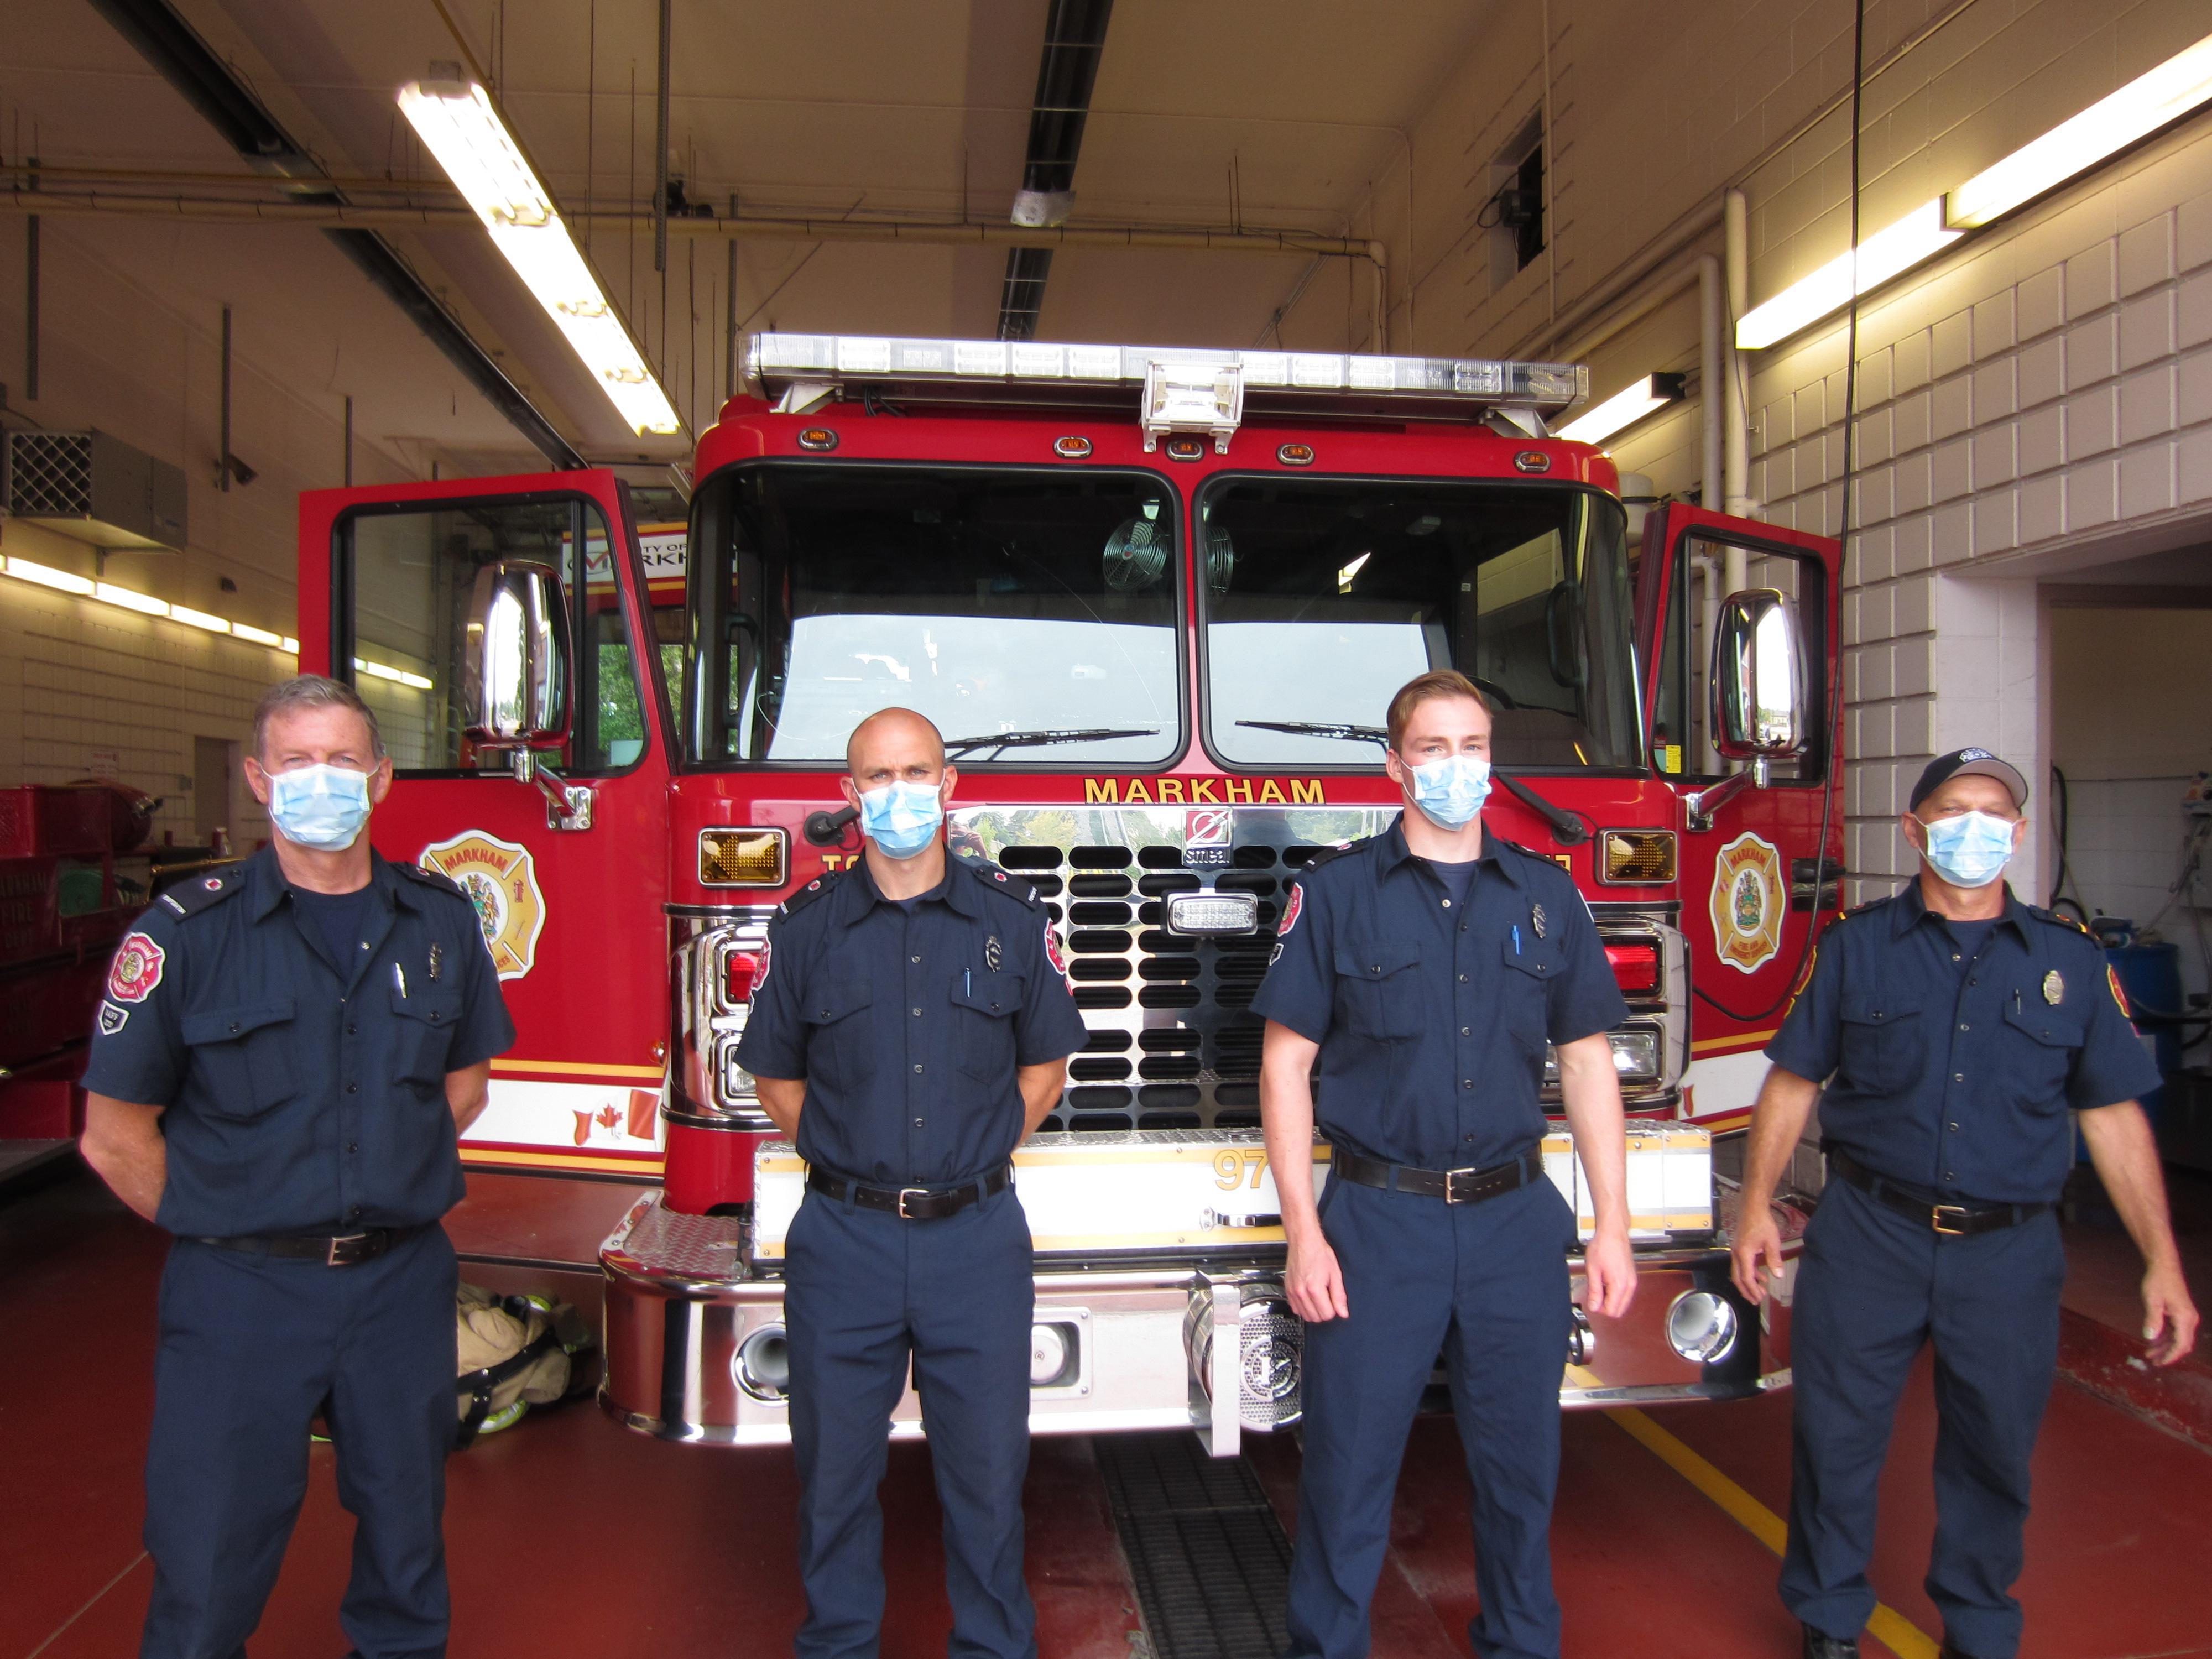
[1252,823,1628,1170]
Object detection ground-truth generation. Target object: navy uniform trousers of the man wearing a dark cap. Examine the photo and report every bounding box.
[1781,1181,2066,1659]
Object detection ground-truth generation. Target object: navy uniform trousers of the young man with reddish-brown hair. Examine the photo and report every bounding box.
[1290,1181,1575,1659]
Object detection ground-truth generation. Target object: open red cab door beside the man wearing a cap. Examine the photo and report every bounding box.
[1637,504,1843,1128]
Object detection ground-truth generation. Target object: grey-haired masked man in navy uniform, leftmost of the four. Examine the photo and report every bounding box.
[84,675,515,1659]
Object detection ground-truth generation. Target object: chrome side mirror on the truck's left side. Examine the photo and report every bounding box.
[460,560,568,752]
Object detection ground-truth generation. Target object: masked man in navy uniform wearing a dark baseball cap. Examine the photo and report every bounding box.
[1734,748,2197,1659]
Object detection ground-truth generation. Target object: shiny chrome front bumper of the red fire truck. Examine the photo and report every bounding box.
[599,1194,1790,1455]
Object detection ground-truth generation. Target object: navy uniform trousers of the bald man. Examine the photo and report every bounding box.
[783,1188,1037,1659]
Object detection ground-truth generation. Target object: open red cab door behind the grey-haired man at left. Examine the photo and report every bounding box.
[299,469,681,1175]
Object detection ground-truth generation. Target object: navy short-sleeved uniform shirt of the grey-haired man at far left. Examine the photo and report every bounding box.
[84,847,515,1237]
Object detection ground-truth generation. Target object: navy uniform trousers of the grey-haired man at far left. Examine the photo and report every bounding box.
[139,1225,458,1659]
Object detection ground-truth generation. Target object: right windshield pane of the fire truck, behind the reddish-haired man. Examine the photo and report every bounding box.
[1199,476,1641,770]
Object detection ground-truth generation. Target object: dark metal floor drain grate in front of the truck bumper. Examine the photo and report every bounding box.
[1091,1431,1290,1659]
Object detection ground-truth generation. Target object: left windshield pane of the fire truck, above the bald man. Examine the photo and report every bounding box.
[686,462,1181,768]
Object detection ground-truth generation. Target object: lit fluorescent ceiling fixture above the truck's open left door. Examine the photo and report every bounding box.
[400,80,684,436]
